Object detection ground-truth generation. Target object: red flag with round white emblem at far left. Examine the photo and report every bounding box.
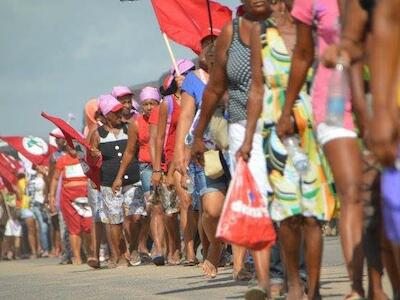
[0,136,49,165]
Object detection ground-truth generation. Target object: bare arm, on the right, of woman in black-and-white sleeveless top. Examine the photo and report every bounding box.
[112,122,138,193]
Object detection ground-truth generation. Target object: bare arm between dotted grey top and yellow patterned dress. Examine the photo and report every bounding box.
[236,23,264,161]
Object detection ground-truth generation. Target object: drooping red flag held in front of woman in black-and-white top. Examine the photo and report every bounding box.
[42,112,102,188]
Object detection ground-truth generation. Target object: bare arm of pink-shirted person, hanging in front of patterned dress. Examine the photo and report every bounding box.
[276,21,314,138]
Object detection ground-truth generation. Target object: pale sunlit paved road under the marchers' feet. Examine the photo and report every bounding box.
[0,239,389,300]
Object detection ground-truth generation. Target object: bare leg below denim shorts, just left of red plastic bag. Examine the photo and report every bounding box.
[201,192,225,278]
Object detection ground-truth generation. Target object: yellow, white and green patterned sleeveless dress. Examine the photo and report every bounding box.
[261,19,337,221]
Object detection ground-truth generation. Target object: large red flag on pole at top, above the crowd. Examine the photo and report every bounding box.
[151,0,232,53]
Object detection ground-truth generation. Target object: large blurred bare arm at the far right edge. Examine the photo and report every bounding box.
[370,0,400,166]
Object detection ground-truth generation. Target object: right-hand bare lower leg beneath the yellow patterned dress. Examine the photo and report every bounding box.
[303,218,322,300]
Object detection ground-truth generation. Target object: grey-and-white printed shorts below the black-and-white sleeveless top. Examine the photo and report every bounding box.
[100,184,147,224]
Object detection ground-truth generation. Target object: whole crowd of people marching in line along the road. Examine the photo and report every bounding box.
[0,0,400,300]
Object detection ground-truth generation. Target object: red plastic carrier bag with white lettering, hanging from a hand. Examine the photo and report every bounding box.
[216,159,276,250]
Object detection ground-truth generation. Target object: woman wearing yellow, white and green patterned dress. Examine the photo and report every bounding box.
[239,1,336,299]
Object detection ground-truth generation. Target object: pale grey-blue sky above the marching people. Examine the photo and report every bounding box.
[0,0,240,137]
